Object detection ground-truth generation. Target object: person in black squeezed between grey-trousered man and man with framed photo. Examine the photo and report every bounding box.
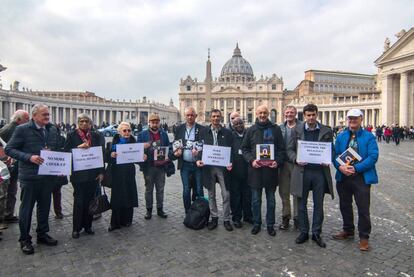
[230,117,253,228]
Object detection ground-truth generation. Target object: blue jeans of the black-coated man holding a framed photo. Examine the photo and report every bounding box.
[252,187,276,227]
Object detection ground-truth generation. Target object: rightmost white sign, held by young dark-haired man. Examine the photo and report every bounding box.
[296,140,332,164]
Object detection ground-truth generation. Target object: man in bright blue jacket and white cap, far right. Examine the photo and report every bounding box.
[333,109,378,251]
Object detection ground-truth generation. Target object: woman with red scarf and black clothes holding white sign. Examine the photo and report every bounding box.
[64,113,105,239]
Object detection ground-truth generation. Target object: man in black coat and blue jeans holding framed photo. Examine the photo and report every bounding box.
[242,105,286,236]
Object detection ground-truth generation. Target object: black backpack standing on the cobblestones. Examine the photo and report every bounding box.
[183,198,210,230]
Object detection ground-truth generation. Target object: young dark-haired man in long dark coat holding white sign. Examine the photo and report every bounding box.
[287,104,333,248]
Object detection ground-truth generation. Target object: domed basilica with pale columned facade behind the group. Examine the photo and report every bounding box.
[179,45,284,124]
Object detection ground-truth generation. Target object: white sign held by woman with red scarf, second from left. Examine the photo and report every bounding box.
[72,146,103,171]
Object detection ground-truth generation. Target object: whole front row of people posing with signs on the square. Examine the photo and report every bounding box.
[0,101,378,254]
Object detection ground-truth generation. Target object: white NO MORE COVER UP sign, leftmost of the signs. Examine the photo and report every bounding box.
[38,150,72,176]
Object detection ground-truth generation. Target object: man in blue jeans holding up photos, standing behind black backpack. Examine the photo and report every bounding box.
[174,107,204,213]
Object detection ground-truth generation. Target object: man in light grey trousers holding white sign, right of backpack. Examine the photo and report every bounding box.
[197,109,233,232]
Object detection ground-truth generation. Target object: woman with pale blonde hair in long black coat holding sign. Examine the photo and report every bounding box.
[108,122,138,232]
